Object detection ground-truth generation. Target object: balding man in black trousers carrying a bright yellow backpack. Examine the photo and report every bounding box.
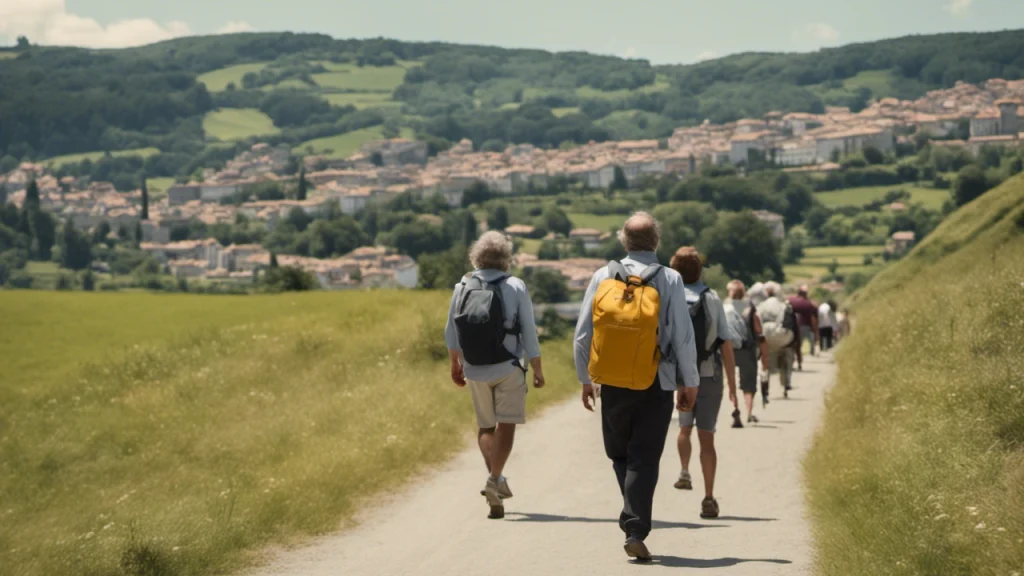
[574,212,699,562]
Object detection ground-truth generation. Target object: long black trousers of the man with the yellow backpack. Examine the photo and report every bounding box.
[601,379,675,540]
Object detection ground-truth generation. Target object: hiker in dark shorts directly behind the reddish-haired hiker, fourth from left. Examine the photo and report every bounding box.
[725,280,768,427]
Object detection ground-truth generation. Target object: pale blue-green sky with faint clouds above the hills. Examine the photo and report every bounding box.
[0,0,1024,64]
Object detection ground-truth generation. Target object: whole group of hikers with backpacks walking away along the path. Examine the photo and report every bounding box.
[444,212,849,562]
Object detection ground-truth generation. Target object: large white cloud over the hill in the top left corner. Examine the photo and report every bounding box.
[0,0,190,48]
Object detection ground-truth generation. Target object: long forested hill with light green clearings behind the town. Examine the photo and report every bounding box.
[0,31,1024,175]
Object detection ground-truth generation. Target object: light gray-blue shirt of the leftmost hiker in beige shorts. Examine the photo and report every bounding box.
[444,269,541,382]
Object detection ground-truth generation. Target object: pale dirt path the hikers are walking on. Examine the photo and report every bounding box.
[247,357,834,576]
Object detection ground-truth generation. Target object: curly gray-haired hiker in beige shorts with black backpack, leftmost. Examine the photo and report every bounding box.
[444,232,545,519]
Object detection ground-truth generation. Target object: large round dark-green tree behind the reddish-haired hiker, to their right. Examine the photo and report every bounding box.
[697,212,783,284]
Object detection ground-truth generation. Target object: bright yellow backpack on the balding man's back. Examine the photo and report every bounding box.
[588,261,662,390]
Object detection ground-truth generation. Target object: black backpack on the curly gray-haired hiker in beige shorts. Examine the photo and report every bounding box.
[455,276,521,369]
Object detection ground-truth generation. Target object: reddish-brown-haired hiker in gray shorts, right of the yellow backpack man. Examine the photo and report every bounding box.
[672,246,739,518]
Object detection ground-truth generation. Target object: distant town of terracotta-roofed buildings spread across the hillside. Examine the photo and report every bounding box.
[0,79,1024,289]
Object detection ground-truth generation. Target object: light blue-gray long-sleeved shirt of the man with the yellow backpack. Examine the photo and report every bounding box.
[574,252,700,390]
